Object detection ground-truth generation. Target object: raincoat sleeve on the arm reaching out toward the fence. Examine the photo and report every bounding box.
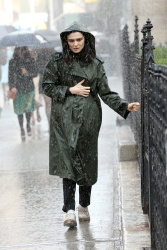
[97,63,130,119]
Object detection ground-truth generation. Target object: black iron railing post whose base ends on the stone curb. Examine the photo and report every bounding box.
[141,19,155,214]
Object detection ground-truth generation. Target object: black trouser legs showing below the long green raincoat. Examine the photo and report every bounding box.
[62,178,92,212]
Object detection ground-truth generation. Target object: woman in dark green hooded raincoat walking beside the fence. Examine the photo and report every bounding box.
[42,22,140,227]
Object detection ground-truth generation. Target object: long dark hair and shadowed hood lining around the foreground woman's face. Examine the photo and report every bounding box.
[62,31,95,67]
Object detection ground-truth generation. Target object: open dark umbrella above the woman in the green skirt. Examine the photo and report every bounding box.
[0,31,47,48]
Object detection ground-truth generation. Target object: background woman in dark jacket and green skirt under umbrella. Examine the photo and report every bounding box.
[9,46,38,141]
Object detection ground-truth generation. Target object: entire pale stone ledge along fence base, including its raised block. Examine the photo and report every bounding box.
[117,118,151,250]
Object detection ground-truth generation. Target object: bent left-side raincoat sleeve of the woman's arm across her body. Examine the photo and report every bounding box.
[42,59,69,102]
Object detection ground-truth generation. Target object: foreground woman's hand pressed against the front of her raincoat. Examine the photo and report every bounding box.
[69,79,90,97]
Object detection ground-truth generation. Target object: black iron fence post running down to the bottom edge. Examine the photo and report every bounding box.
[145,19,161,249]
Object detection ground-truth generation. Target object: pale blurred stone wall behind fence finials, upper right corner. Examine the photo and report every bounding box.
[126,0,167,46]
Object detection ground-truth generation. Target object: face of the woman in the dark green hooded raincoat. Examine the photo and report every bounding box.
[67,32,85,53]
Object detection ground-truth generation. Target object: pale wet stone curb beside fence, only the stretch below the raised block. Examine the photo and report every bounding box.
[120,161,151,250]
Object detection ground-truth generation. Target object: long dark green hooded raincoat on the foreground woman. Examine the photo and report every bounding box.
[43,23,129,186]
